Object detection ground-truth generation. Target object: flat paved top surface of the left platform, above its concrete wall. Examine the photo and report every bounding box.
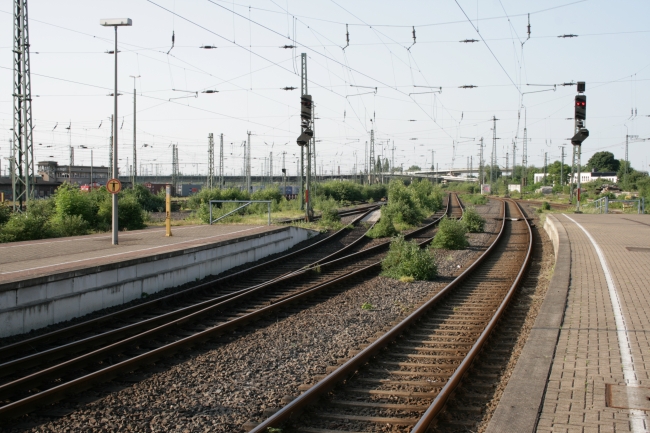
[0,224,282,285]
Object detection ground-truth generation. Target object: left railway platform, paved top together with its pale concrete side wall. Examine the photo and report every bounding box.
[0,224,316,337]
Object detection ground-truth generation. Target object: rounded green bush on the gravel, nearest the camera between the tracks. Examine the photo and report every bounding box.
[381,236,438,281]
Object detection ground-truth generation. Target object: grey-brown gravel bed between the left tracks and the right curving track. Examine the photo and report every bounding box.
[5,202,500,433]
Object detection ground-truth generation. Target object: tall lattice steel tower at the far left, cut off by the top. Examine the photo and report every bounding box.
[12,0,35,211]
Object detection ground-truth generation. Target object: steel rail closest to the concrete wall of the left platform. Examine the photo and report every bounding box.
[0,208,376,362]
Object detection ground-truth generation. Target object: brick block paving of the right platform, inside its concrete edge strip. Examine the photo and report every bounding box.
[537,214,650,433]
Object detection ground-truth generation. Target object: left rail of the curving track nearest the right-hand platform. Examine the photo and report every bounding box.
[250,197,506,433]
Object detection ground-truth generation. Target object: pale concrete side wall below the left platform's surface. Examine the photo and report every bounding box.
[0,227,316,337]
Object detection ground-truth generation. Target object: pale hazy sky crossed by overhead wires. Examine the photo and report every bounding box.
[0,0,650,179]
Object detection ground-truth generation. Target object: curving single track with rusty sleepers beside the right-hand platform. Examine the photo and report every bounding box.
[251,200,532,433]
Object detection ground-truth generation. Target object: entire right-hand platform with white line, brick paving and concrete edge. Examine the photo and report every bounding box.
[487,214,650,433]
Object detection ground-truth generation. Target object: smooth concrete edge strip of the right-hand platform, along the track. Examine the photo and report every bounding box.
[486,214,571,433]
